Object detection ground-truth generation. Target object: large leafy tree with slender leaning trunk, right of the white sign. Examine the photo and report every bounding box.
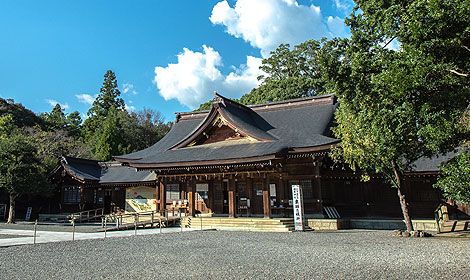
[334,0,470,231]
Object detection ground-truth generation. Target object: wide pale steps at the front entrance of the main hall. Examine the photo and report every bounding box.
[182,217,294,232]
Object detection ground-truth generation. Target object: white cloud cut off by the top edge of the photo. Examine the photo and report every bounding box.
[209,0,343,57]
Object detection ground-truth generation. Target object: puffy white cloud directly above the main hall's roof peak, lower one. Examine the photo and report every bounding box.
[154,45,262,109]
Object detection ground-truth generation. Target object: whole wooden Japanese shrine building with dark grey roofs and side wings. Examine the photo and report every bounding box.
[54,94,448,230]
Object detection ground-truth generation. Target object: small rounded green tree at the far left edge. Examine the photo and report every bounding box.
[0,133,48,223]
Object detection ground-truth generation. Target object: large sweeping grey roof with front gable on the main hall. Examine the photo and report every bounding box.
[114,94,339,168]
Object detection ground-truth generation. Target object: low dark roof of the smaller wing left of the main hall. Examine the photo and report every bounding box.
[55,156,155,185]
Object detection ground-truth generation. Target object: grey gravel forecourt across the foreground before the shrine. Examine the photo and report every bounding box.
[0,230,470,279]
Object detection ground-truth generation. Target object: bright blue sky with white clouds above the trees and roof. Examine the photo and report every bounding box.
[0,0,353,121]
